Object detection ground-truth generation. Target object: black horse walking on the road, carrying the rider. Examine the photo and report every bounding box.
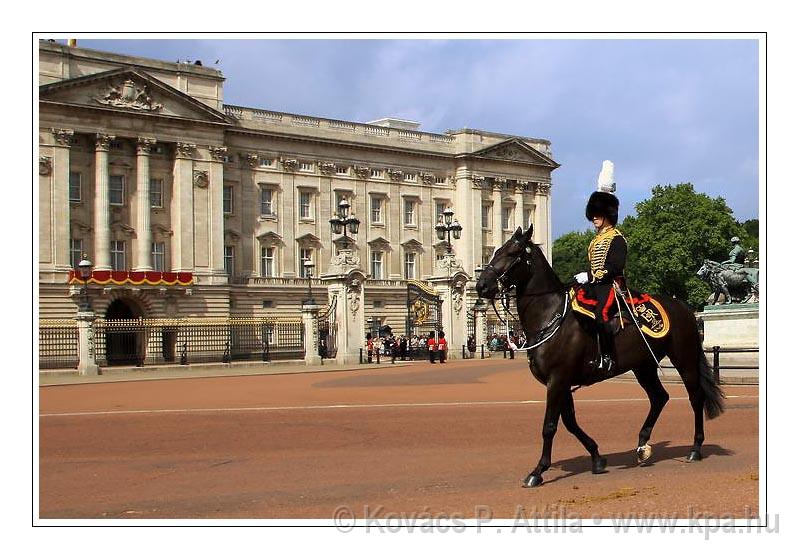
[476,225,725,488]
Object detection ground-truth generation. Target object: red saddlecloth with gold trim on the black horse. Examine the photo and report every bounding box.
[569,286,669,338]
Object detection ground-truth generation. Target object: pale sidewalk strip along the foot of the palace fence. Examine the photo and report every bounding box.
[39,358,419,387]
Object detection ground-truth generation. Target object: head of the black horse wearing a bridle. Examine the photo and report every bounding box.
[475,224,533,299]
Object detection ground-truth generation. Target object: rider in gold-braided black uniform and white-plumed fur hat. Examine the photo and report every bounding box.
[575,160,628,375]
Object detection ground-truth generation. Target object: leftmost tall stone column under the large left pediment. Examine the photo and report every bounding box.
[50,128,74,270]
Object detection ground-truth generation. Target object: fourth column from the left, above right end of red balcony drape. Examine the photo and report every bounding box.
[170,142,196,272]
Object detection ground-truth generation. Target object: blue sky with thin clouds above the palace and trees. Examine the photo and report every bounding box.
[72,39,759,238]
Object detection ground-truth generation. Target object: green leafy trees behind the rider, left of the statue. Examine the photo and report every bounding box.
[553,183,758,309]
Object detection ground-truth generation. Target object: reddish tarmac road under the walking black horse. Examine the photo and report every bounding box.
[39,360,759,522]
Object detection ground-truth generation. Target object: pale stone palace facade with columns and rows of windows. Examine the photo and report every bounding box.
[39,41,558,336]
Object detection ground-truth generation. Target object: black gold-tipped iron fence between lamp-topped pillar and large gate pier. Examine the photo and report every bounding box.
[94,318,305,366]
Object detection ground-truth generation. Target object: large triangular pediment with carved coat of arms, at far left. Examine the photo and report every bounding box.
[39,68,230,124]
